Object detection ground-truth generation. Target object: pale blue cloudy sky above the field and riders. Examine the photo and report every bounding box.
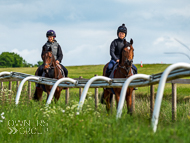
[0,0,190,66]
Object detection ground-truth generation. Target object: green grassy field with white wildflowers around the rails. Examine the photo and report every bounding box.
[0,64,190,143]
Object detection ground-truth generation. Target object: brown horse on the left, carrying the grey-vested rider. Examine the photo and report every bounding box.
[33,47,64,102]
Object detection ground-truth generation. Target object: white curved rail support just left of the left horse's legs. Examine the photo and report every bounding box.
[15,76,40,105]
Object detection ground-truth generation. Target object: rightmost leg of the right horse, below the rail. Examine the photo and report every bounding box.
[126,88,133,115]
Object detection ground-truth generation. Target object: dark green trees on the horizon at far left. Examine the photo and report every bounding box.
[0,52,43,68]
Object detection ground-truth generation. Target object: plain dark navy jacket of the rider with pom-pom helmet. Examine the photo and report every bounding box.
[110,38,129,61]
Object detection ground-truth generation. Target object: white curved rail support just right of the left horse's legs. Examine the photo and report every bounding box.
[46,78,78,105]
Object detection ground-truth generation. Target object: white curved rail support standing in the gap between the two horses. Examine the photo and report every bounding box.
[77,76,112,114]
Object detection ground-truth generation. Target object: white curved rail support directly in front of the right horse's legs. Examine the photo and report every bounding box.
[116,74,151,119]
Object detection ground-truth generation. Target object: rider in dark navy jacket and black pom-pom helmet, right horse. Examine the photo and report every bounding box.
[106,24,137,76]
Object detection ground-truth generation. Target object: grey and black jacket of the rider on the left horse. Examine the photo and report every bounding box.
[41,40,63,63]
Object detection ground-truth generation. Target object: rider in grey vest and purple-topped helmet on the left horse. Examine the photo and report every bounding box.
[38,30,68,77]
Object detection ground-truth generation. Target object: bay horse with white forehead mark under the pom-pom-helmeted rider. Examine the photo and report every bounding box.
[102,39,134,115]
